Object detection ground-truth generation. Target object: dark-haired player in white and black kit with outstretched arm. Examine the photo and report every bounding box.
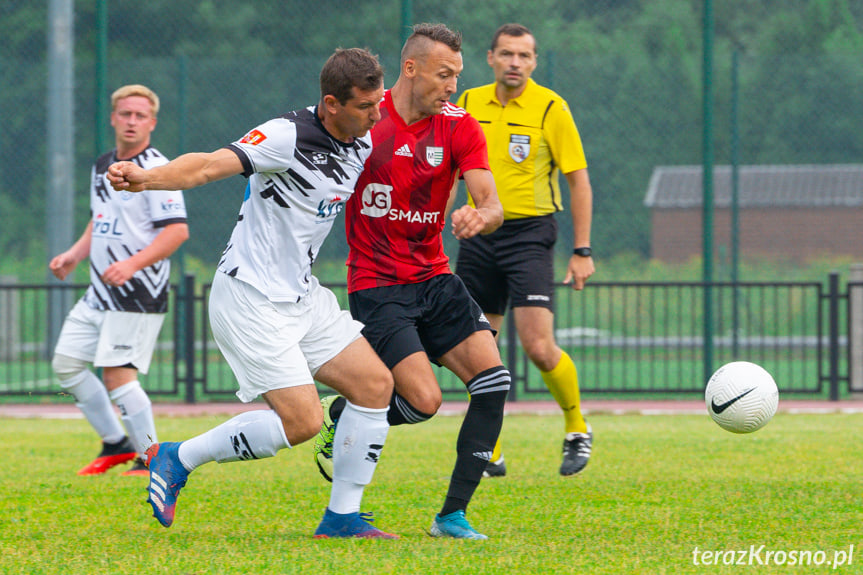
[109,48,396,539]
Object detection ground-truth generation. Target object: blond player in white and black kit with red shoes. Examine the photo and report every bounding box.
[49,84,189,475]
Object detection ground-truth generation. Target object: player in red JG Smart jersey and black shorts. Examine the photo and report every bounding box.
[318,24,510,539]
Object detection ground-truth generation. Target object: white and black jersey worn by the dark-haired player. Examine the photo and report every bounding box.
[219,106,371,302]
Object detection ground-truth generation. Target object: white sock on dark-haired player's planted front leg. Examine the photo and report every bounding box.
[329,401,390,513]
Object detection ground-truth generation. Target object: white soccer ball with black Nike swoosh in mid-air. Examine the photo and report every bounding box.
[704,361,779,433]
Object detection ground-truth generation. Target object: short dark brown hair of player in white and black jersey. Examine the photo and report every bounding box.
[321,48,384,105]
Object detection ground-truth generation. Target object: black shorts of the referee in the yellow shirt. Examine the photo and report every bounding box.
[456,215,557,315]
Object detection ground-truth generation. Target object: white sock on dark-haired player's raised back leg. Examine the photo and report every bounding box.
[177,409,291,471]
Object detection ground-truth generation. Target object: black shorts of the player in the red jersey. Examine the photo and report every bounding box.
[348,274,491,369]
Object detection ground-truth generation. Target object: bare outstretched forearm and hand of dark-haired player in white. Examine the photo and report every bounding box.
[108,148,243,192]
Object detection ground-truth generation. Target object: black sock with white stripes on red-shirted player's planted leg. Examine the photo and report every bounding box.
[442,365,510,516]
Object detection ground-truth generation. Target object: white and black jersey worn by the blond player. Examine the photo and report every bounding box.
[84,147,186,313]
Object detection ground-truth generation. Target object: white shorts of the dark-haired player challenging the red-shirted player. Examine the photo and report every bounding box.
[210,272,363,402]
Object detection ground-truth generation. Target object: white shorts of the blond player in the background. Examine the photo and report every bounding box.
[54,299,165,373]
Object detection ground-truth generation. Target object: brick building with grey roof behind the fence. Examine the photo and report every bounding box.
[644,164,863,262]
